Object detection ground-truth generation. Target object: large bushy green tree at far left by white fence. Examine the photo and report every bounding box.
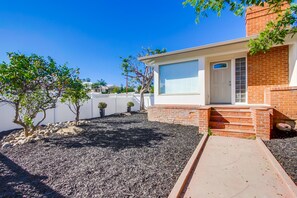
[0,53,76,136]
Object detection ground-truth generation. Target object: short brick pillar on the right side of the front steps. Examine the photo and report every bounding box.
[252,108,273,140]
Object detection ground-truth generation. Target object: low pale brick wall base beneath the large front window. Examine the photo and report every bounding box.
[148,105,200,126]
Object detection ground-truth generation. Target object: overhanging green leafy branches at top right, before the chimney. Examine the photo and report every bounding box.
[183,0,297,54]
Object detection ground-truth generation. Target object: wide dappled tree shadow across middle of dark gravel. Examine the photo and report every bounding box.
[47,126,169,151]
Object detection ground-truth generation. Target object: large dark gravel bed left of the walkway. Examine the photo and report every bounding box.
[0,114,202,197]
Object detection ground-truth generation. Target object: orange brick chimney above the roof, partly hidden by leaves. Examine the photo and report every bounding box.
[245,3,290,36]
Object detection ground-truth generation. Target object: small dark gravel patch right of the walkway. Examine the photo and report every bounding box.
[265,131,297,185]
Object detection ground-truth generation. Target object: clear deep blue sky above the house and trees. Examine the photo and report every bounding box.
[0,0,245,85]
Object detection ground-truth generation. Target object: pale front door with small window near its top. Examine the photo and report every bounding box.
[210,61,231,104]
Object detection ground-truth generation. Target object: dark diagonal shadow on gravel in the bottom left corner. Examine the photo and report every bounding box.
[0,153,64,197]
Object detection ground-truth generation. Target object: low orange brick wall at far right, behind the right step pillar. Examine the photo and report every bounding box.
[267,87,297,128]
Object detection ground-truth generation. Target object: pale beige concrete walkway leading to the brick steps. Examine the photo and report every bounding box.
[183,136,292,198]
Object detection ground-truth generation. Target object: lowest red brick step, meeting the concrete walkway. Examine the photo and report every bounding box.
[210,129,256,139]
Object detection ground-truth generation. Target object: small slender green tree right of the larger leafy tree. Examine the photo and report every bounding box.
[61,77,90,124]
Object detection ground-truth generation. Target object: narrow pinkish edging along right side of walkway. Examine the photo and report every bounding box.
[256,138,297,197]
